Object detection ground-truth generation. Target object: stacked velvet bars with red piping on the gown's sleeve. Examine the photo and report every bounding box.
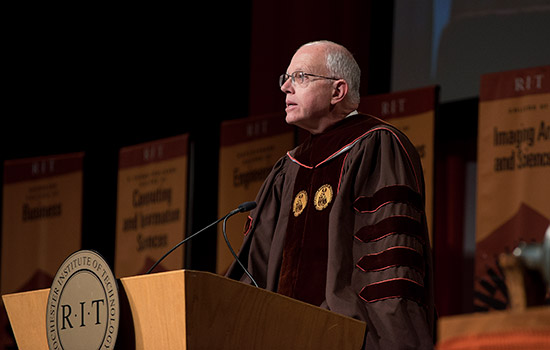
[354,184,428,305]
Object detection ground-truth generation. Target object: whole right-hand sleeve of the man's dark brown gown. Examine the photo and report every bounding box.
[326,126,434,349]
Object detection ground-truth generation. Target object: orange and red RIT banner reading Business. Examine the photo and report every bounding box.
[2,153,83,294]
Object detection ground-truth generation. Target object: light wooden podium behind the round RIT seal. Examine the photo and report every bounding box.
[2,270,365,350]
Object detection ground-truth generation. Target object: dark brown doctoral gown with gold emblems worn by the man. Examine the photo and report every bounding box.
[228,114,434,349]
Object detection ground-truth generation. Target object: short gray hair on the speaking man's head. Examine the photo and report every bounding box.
[303,40,361,104]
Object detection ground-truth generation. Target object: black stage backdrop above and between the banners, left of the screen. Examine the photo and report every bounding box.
[0,1,392,276]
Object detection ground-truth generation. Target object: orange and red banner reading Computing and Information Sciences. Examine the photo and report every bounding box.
[115,134,188,278]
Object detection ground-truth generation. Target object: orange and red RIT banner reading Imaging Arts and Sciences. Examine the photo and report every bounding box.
[474,66,550,309]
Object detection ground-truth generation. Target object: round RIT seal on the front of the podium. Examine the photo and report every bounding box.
[46,250,120,350]
